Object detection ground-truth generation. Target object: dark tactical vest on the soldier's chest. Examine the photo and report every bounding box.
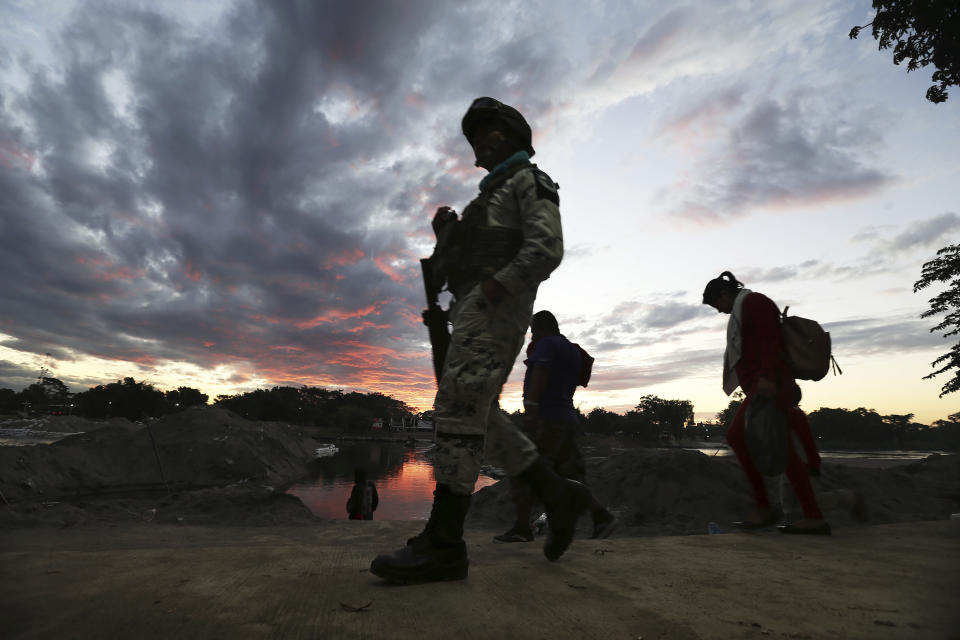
[435,162,532,298]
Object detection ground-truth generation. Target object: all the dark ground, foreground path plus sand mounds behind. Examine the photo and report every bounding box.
[0,407,960,640]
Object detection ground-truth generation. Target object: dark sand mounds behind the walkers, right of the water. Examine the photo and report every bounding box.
[468,449,960,535]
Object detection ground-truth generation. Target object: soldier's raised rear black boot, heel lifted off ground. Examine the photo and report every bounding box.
[518,458,590,560]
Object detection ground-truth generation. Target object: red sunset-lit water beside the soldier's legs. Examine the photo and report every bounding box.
[287,442,496,520]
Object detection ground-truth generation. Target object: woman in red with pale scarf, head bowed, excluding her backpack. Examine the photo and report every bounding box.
[703,271,830,535]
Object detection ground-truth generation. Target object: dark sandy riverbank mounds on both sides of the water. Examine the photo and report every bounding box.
[0,407,960,536]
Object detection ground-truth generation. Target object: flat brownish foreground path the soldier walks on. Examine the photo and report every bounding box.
[0,521,960,640]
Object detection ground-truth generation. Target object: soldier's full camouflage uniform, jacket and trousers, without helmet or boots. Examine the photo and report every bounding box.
[434,160,563,495]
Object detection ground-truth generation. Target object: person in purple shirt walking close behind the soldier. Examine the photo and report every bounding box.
[493,311,618,542]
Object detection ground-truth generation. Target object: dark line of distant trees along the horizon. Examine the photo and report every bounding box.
[0,377,960,450]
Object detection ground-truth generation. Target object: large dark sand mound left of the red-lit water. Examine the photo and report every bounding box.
[0,407,318,503]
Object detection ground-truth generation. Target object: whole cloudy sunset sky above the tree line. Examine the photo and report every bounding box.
[0,0,960,422]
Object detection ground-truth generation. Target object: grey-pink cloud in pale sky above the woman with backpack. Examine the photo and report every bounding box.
[660,87,892,220]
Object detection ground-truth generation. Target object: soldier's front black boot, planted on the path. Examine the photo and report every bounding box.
[370,484,470,584]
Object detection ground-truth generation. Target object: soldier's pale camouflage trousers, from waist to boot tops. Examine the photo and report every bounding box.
[433,286,537,495]
